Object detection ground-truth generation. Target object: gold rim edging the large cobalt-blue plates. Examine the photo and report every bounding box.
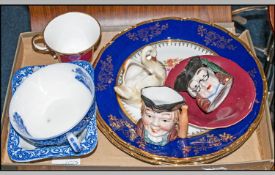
[93,17,267,165]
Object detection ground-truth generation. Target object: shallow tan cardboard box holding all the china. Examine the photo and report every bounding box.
[1,28,274,170]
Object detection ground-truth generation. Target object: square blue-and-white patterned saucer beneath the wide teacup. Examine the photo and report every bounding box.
[7,61,97,162]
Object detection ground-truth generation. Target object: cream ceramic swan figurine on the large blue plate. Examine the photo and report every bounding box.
[114,46,166,107]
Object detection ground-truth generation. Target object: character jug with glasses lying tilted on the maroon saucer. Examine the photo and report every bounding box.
[175,57,233,113]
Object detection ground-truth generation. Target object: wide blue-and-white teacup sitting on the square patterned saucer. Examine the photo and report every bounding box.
[9,61,95,152]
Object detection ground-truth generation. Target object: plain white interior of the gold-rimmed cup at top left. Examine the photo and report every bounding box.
[44,12,100,54]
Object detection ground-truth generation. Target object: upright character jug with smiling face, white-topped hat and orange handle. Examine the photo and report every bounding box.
[137,86,188,146]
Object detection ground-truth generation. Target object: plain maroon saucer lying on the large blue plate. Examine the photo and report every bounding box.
[165,55,256,129]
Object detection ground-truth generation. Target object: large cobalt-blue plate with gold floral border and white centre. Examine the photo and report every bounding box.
[95,18,266,164]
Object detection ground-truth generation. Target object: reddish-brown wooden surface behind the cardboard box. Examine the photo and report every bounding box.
[29,6,232,31]
